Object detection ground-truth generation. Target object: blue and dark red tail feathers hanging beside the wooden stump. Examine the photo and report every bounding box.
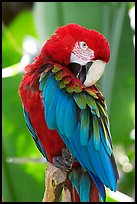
[65,167,100,202]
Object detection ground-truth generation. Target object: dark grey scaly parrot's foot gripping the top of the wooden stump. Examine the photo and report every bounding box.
[53,148,76,171]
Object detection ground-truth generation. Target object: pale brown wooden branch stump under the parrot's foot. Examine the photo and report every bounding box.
[42,162,67,202]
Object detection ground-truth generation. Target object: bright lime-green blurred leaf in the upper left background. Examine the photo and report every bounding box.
[2,10,37,67]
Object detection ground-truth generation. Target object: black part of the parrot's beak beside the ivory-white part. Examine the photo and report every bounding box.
[69,62,93,83]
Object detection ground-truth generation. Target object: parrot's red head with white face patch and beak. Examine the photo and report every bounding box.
[41,24,110,87]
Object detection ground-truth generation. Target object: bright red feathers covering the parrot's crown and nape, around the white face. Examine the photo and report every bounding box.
[33,24,110,66]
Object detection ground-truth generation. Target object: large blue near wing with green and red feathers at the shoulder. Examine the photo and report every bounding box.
[40,67,118,199]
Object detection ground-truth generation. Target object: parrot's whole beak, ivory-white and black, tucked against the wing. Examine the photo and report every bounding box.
[69,60,106,87]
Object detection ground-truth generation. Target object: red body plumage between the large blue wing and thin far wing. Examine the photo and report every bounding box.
[19,72,65,163]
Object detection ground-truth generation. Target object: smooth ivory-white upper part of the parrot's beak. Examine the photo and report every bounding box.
[84,60,106,87]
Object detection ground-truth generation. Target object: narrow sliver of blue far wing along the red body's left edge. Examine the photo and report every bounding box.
[23,108,47,158]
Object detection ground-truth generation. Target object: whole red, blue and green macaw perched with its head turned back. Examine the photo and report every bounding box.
[18,23,119,202]
